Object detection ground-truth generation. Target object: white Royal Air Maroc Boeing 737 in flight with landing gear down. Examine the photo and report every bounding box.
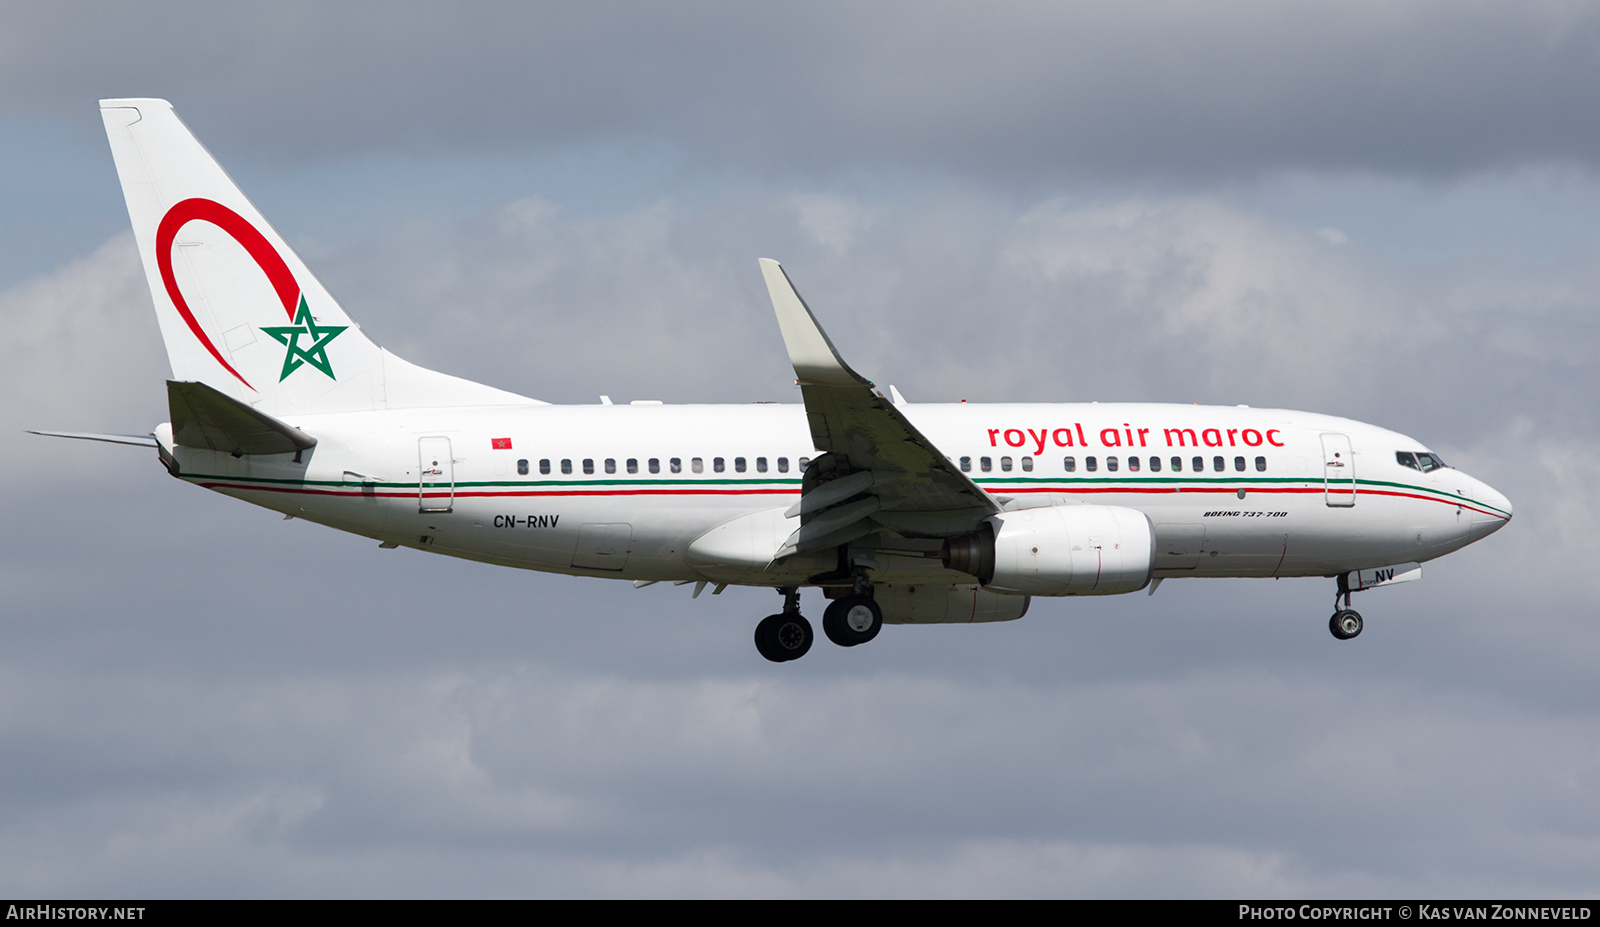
[34,99,1510,661]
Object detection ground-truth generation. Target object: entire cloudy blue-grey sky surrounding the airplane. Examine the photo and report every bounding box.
[0,0,1600,897]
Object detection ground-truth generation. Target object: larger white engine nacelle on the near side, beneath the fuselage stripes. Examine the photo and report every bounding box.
[942,506,1155,596]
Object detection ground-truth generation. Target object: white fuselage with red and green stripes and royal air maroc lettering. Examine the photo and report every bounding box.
[158,403,1510,584]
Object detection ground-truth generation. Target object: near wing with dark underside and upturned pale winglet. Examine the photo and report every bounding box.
[762,258,1000,557]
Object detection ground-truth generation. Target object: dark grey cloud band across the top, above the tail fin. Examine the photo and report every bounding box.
[0,2,1600,184]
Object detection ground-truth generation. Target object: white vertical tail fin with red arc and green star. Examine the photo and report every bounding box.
[101,99,536,415]
